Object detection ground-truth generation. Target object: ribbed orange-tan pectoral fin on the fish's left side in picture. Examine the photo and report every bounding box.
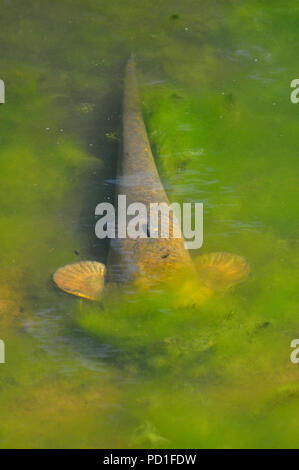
[53,261,106,300]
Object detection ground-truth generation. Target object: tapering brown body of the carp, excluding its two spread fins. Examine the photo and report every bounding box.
[108,58,194,285]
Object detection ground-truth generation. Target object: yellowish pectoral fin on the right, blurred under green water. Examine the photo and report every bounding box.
[194,251,250,290]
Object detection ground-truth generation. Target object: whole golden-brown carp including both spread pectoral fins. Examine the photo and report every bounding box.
[53,57,249,305]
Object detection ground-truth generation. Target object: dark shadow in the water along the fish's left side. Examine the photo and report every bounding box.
[71,75,122,263]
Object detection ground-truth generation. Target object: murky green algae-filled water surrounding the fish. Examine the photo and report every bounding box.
[0,0,299,448]
